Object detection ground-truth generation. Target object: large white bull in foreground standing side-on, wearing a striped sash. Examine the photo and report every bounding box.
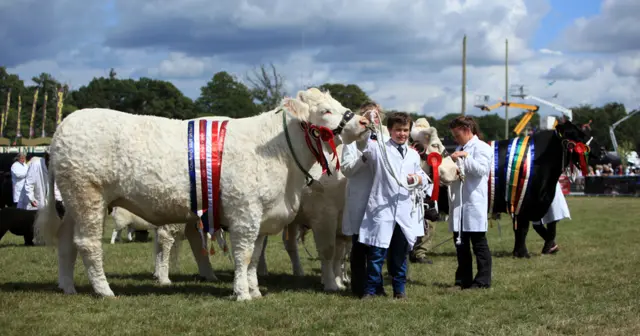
[35,88,369,300]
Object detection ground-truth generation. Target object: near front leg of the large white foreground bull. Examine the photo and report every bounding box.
[229,228,262,301]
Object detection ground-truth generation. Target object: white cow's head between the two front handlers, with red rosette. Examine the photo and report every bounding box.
[411,118,458,186]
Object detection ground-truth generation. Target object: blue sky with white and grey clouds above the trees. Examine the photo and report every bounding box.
[0,0,640,118]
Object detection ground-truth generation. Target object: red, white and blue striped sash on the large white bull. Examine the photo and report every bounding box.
[187,119,228,253]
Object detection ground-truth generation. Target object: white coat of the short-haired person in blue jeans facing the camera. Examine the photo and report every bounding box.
[359,139,429,249]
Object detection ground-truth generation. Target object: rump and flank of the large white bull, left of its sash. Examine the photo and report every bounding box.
[50,108,189,223]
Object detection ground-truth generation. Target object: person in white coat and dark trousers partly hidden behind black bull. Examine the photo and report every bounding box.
[533,182,571,254]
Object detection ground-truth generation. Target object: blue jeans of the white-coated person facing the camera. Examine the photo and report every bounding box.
[365,223,409,295]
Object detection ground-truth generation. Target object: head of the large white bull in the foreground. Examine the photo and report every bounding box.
[283,88,369,144]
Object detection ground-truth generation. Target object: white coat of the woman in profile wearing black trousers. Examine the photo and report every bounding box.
[449,135,493,232]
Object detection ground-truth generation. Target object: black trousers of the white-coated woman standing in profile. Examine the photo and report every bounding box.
[453,232,491,288]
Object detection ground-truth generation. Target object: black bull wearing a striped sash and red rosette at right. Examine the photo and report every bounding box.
[412,121,606,258]
